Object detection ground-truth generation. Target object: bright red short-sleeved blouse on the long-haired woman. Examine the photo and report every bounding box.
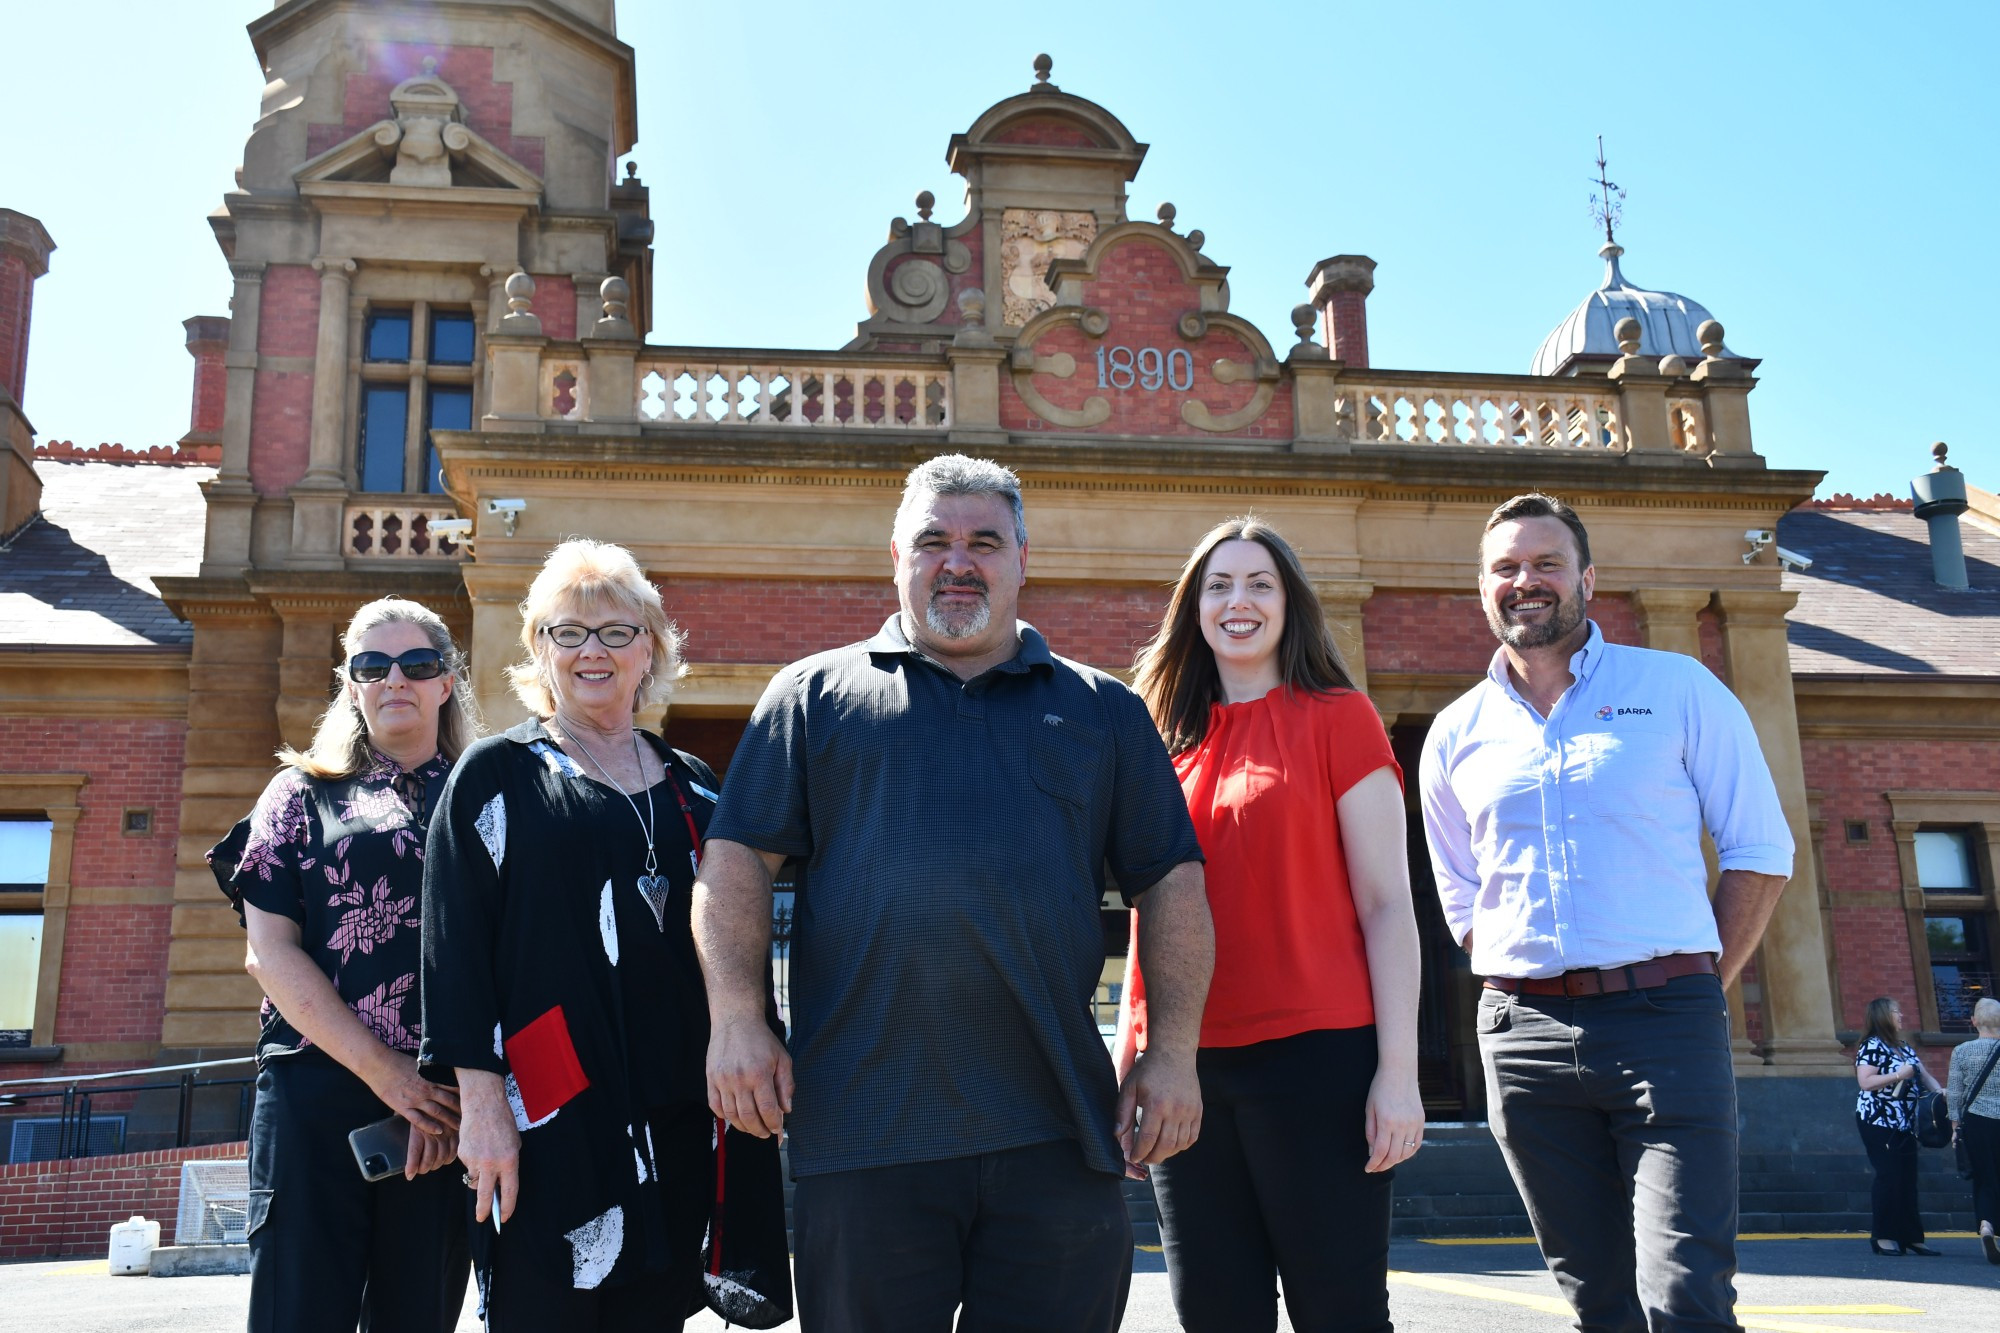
[1130,689,1404,1047]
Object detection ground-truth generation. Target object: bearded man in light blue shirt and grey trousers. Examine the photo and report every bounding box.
[1418,494,1792,1333]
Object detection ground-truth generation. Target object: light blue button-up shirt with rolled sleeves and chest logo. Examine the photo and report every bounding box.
[1418,622,1792,977]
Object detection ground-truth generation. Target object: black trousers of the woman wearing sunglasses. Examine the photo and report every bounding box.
[250,1051,470,1333]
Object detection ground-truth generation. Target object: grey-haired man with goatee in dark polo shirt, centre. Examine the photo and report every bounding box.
[694,454,1214,1333]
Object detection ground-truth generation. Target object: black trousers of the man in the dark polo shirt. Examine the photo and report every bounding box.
[792,1139,1132,1333]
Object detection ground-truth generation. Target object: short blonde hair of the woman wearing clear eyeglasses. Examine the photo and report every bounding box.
[506,536,688,719]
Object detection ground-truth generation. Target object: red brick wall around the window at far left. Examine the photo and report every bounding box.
[0,717,186,1056]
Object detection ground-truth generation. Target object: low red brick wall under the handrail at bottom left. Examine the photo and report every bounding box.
[0,1143,248,1259]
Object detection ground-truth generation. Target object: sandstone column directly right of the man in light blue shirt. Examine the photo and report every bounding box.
[1716,588,1852,1071]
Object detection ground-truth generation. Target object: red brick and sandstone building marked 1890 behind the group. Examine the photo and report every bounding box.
[0,0,2000,1160]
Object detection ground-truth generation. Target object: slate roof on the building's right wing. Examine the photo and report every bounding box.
[1778,508,2000,681]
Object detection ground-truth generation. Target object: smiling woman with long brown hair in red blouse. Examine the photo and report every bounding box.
[1114,518,1424,1333]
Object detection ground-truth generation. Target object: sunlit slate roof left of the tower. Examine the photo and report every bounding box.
[0,458,216,648]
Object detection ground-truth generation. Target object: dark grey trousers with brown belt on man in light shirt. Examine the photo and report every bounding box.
[1478,964,1742,1333]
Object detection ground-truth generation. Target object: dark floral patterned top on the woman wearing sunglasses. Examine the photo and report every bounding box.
[208,755,452,1061]
